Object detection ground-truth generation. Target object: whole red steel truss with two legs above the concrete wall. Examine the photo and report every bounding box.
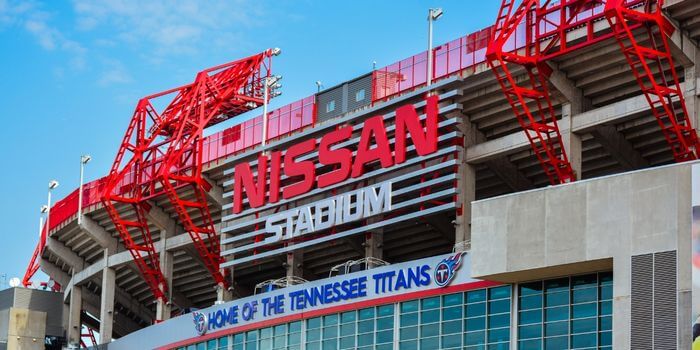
[486,0,700,184]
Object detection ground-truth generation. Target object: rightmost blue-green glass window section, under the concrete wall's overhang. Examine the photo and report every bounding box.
[518,272,612,350]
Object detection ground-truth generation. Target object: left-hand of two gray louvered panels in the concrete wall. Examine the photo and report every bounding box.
[630,254,654,350]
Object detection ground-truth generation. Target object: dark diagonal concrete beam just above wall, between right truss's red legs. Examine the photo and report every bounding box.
[591,125,649,170]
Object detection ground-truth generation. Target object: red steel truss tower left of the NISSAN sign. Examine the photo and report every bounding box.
[102,49,278,301]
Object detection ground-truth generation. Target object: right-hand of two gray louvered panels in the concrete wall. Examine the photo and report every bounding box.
[654,251,677,349]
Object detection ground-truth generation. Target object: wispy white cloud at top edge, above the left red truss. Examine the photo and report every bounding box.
[73,0,263,60]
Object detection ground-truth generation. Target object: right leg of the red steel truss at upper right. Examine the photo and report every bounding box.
[605,0,700,162]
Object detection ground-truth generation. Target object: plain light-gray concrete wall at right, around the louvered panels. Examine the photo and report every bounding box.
[472,164,692,349]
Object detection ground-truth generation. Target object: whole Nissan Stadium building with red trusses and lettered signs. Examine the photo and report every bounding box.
[9,0,700,350]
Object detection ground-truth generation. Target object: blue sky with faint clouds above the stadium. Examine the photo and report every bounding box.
[0,0,500,287]
